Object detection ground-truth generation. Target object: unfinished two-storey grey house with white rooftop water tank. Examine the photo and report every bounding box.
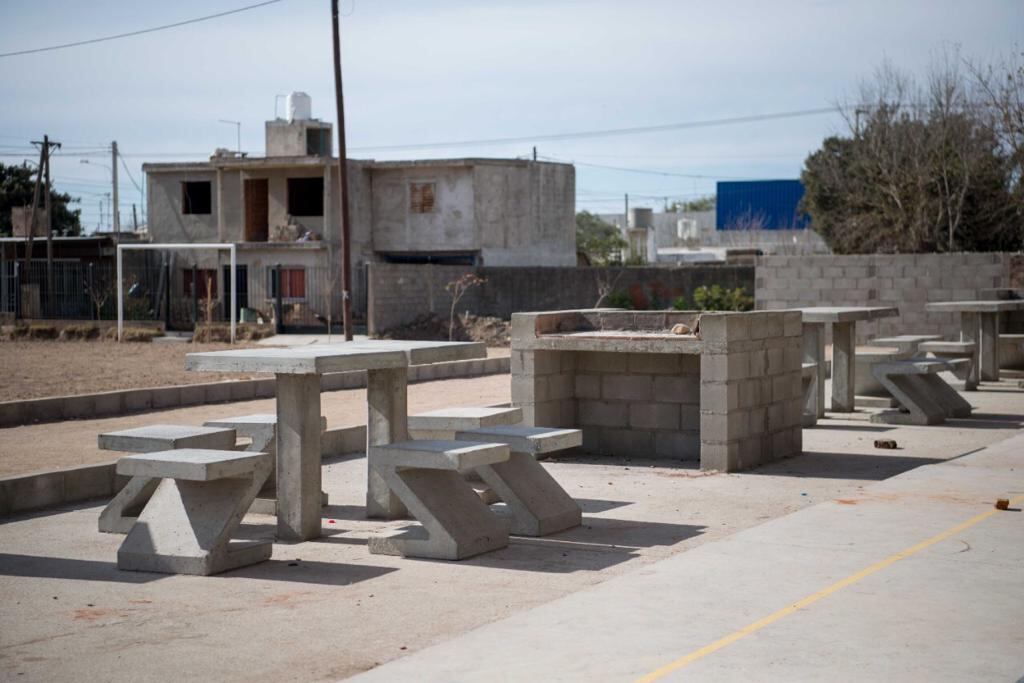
[142,93,575,323]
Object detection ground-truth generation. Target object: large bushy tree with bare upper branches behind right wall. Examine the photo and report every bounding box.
[801,52,1021,254]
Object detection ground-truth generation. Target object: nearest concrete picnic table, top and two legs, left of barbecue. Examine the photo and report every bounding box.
[185,340,487,541]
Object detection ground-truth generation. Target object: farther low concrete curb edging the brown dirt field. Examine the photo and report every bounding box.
[0,357,511,427]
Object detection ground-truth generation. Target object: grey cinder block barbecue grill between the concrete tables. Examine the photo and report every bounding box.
[512,309,803,471]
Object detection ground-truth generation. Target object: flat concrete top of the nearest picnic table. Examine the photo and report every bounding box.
[185,340,487,375]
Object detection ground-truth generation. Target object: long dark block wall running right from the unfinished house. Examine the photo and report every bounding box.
[367,263,754,334]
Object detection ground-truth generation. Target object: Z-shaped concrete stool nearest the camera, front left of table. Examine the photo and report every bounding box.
[117,449,272,575]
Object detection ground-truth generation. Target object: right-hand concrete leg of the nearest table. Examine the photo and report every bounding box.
[367,368,409,519]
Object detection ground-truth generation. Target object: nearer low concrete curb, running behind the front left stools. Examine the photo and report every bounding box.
[0,425,367,517]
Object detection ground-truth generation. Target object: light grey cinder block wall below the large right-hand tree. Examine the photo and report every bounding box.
[755,253,1021,344]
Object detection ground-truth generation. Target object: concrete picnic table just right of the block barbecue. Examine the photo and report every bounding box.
[797,306,899,418]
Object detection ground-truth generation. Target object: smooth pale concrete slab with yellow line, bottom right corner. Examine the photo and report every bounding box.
[354,435,1024,682]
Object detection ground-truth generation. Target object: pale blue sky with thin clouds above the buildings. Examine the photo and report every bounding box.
[0,0,1024,230]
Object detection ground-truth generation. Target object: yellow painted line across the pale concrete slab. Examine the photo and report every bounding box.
[637,496,1024,683]
